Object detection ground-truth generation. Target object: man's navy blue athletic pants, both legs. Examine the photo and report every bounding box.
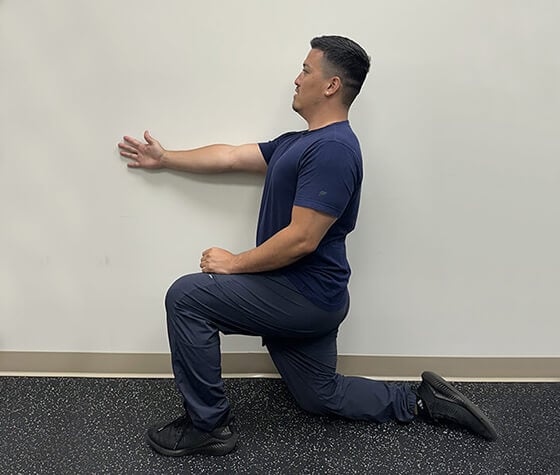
[165,273,416,431]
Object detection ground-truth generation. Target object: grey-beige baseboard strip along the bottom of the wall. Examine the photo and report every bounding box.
[0,351,560,381]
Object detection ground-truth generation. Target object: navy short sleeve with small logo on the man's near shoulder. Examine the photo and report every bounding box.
[294,141,362,218]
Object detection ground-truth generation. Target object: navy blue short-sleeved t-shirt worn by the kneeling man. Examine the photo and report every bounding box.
[257,121,363,311]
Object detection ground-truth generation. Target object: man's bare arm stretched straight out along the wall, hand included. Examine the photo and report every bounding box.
[119,131,266,173]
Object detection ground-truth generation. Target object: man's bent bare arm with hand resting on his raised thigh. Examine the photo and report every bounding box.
[200,206,336,274]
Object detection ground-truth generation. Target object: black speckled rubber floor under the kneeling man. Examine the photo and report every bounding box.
[0,377,560,475]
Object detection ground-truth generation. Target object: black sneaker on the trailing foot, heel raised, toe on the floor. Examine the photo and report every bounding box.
[416,371,498,440]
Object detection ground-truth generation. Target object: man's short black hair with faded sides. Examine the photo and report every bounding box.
[311,35,370,107]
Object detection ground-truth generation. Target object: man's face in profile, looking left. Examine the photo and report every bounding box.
[292,49,329,116]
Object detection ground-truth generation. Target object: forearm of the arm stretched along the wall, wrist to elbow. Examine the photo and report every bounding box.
[161,144,235,173]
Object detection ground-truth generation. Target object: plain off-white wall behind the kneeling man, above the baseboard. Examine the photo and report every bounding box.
[0,0,560,355]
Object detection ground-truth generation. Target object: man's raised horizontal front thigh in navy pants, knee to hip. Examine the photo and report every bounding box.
[166,273,346,338]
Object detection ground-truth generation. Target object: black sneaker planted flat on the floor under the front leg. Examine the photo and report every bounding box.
[146,415,239,457]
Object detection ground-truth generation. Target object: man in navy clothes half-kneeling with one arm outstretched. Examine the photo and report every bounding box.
[119,36,496,456]
